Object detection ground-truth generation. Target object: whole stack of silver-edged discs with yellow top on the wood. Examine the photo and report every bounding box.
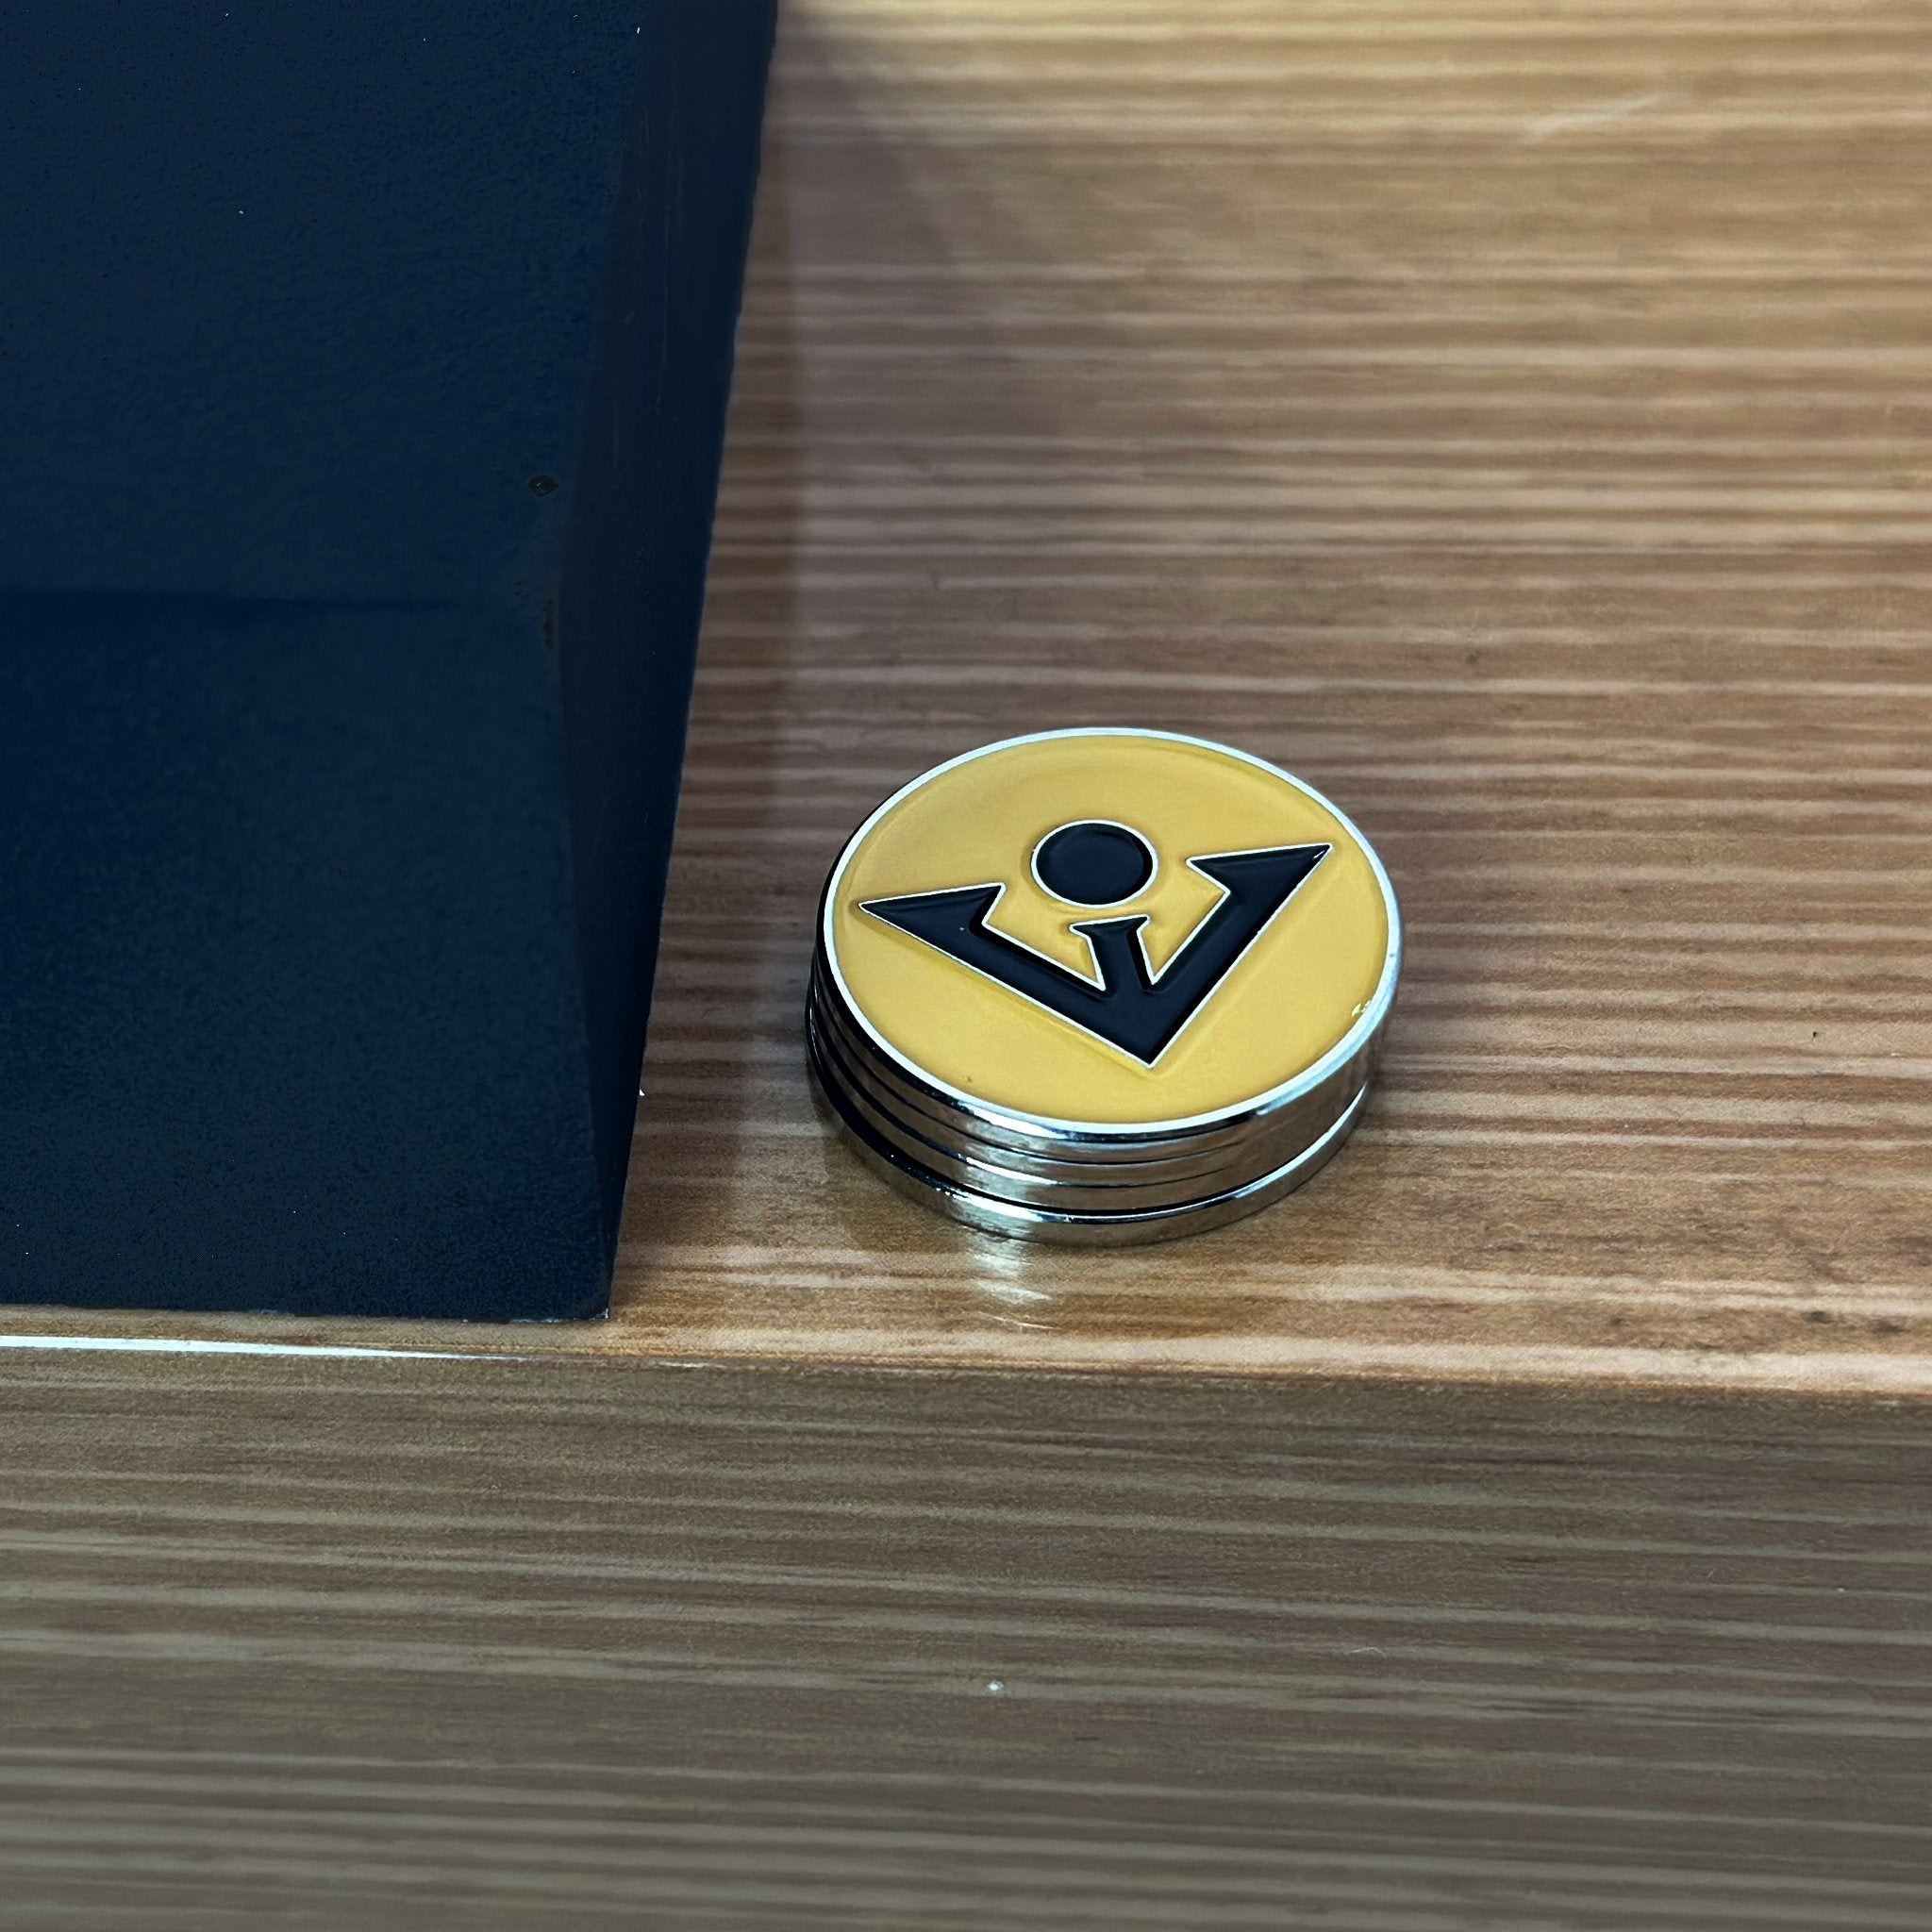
[811,730,1401,1239]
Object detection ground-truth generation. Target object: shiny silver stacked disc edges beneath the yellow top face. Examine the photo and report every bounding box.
[808,947,1374,1244]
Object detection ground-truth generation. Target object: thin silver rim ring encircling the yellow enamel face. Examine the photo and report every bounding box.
[815,724,1403,1145]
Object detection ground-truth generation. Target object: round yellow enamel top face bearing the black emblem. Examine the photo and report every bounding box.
[823,730,1399,1126]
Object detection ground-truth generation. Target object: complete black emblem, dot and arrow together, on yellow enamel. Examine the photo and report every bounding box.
[863,819,1331,1066]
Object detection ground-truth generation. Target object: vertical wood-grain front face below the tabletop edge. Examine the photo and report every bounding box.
[0,1357,1932,1932]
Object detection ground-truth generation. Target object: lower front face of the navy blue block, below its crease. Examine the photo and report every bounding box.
[0,595,603,1316]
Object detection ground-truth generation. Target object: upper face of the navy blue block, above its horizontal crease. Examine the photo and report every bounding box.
[0,0,645,597]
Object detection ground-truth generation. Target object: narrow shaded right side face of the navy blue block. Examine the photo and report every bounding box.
[560,0,773,1241]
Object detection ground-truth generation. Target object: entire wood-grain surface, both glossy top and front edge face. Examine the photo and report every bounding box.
[0,11,1932,1932]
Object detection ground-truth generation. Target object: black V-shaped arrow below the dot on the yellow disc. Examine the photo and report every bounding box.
[861,844,1331,1066]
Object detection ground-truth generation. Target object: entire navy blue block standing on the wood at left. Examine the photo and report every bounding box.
[0,0,771,1318]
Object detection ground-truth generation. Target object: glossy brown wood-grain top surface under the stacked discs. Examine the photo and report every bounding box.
[6,0,1932,1393]
